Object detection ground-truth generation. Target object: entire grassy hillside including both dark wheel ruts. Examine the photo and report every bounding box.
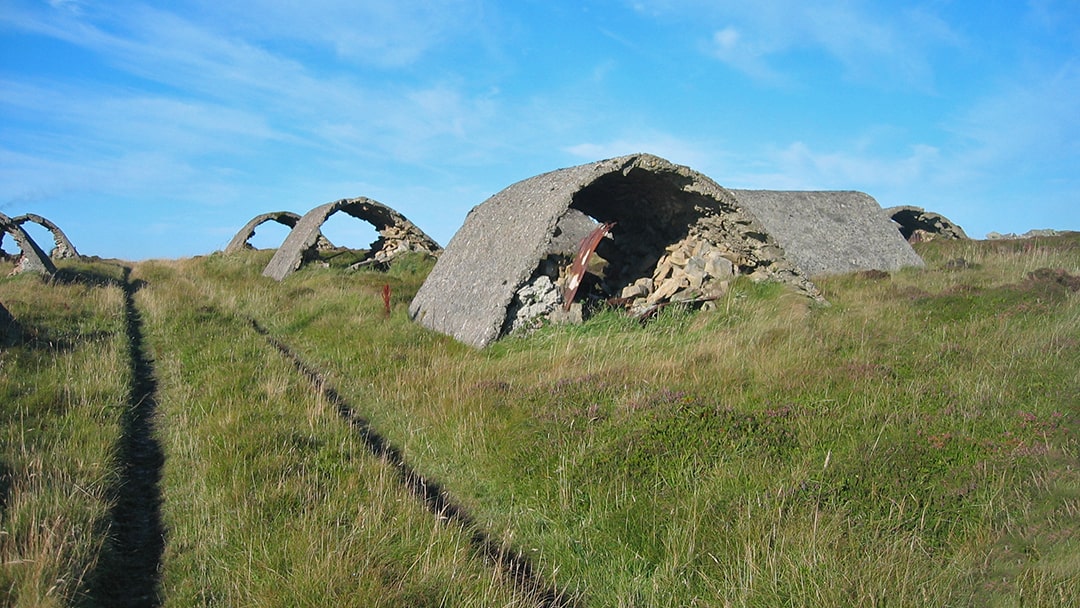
[0,233,1080,607]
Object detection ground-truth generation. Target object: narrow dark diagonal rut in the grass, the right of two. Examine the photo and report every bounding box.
[252,320,580,608]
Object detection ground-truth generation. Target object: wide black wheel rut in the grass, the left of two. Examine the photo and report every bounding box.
[80,268,165,607]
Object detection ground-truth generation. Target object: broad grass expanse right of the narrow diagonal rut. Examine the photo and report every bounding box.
[217,238,1080,606]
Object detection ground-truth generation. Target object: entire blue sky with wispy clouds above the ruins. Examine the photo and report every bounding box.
[0,0,1080,260]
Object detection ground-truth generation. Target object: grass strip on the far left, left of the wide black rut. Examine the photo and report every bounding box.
[0,264,130,606]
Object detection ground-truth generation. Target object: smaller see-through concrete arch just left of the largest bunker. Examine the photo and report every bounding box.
[262,197,442,281]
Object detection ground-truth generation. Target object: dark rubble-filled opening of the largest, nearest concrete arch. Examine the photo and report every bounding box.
[504,168,747,333]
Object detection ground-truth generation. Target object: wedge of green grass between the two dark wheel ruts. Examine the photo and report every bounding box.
[130,260,548,607]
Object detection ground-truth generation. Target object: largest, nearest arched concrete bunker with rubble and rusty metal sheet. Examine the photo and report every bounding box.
[409,154,820,347]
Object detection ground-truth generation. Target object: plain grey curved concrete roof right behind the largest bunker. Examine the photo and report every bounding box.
[731,190,924,276]
